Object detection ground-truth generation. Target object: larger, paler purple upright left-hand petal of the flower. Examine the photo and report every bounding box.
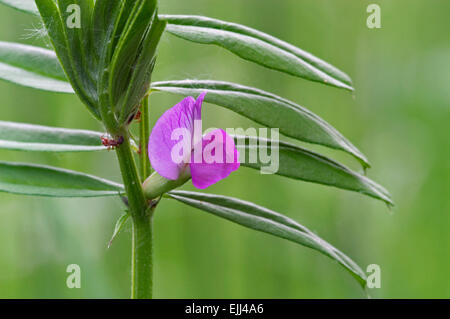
[148,96,196,180]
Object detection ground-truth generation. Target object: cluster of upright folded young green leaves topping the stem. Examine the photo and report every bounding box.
[36,0,166,133]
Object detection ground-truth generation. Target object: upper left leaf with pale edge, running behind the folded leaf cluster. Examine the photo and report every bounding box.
[0,41,73,93]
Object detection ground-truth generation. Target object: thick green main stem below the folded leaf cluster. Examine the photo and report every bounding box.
[116,128,153,299]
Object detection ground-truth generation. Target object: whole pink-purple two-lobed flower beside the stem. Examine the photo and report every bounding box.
[148,92,240,189]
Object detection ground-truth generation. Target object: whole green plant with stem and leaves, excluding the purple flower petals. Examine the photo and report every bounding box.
[0,0,393,298]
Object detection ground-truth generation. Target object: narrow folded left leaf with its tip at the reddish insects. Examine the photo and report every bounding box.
[0,121,106,152]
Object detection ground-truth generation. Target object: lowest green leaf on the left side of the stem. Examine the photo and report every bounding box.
[0,162,124,197]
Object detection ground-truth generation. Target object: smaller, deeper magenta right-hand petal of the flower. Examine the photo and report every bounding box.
[190,129,240,189]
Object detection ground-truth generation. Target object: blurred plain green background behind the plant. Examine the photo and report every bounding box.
[0,0,450,298]
